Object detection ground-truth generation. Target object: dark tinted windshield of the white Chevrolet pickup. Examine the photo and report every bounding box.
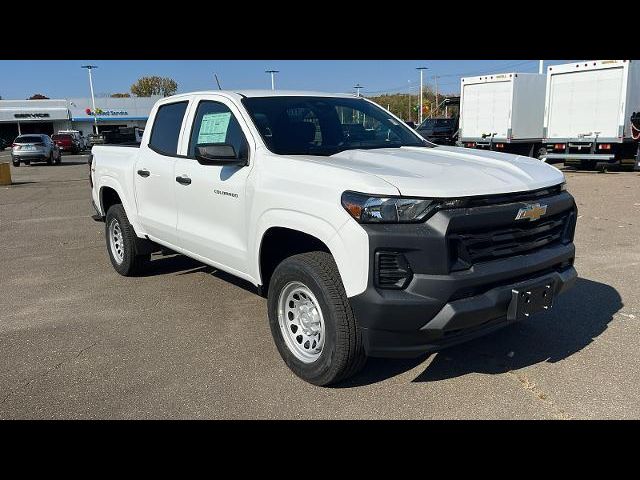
[242,97,433,156]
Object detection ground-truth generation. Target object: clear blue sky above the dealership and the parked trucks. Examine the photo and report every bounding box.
[0,60,571,100]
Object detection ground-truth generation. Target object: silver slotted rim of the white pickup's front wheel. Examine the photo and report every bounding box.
[278,282,325,363]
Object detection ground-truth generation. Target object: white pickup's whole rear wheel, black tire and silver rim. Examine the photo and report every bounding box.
[105,204,149,277]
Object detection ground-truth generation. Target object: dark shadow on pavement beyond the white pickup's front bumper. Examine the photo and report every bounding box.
[336,278,623,388]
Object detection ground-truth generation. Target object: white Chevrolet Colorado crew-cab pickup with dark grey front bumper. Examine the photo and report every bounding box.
[89,91,577,385]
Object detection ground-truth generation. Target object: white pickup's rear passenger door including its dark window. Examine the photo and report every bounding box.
[134,100,189,245]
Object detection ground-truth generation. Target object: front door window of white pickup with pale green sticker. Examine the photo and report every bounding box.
[188,100,249,160]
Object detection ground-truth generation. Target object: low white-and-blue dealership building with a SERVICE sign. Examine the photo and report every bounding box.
[0,96,161,141]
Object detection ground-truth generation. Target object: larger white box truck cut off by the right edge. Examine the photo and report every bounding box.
[540,60,640,168]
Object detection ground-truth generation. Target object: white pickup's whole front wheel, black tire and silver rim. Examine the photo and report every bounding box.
[268,252,366,386]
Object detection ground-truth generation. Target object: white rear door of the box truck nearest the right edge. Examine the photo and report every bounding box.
[547,66,624,138]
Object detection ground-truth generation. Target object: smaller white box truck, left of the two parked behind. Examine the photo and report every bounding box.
[460,73,546,157]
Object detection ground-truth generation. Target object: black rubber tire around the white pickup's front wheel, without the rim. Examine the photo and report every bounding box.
[268,251,367,386]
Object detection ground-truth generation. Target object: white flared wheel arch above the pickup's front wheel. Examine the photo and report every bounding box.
[250,209,369,297]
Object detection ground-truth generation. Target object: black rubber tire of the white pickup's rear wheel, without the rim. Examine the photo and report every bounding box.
[105,204,150,277]
